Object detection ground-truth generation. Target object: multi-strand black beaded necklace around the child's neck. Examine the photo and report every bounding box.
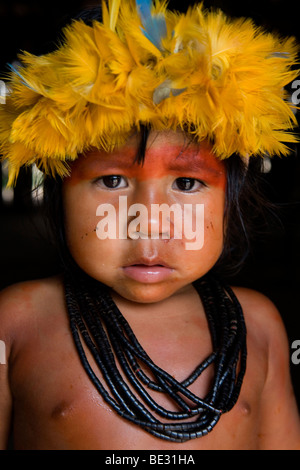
[65,272,247,442]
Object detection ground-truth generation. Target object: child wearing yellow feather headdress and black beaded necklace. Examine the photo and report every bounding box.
[0,0,300,450]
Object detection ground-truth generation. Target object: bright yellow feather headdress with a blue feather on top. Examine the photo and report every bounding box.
[0,0,298,185]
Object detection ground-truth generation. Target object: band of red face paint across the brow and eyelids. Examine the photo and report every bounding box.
[65,130,225,188]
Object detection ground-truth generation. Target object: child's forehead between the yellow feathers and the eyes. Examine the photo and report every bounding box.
[68,131,224,178]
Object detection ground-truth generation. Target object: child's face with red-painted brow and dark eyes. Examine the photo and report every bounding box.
[63,131,226,302]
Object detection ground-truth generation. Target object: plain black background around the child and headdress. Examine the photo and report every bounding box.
[0,0,300,414]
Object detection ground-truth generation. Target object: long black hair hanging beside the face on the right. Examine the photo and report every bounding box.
[215,155,268,275]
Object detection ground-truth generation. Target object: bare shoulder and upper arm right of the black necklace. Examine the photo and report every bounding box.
[234,288,300,450]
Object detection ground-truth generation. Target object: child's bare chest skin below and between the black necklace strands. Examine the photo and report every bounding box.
[9,302,257,450]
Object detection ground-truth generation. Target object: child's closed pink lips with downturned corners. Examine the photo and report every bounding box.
[123,259,174,284]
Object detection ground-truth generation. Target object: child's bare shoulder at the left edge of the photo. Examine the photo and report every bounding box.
[0,276,63,352]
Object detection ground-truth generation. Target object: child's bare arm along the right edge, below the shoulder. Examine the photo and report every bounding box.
[259,304,300,450]
